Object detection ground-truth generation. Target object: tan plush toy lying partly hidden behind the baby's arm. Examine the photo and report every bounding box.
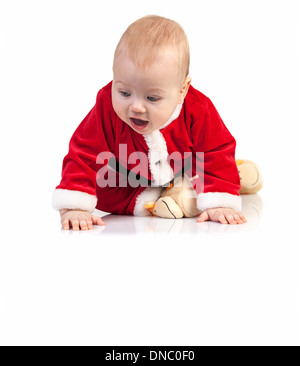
[145,160,262,219]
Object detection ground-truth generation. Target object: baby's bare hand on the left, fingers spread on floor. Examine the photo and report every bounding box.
[60,209,105,231]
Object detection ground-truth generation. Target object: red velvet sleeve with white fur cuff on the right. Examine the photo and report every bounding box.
[191,97,241,211]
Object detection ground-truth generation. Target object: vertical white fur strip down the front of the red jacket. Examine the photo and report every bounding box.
[143,130,174,187]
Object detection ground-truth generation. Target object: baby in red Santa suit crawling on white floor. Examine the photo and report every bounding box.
[53,16,246,230]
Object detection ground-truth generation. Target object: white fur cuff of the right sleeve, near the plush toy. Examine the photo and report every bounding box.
[197,192,242,212]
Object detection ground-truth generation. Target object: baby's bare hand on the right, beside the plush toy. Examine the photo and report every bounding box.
[197,207,247,225]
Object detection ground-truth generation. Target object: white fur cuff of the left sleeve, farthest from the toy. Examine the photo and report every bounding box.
[52,189,97,212]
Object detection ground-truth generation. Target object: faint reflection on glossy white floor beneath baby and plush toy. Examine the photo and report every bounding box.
[64,194,263,235]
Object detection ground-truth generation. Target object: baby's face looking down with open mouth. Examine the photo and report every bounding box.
[112,50,186,134]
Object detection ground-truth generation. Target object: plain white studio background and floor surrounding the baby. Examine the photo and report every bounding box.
[0,0,300,346]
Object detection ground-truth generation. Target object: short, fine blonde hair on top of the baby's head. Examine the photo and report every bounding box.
[114,15,190,83]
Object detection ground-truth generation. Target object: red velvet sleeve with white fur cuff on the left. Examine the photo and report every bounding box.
[53,84,115,211]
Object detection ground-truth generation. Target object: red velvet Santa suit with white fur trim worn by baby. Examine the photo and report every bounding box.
[53,82,241,216]
